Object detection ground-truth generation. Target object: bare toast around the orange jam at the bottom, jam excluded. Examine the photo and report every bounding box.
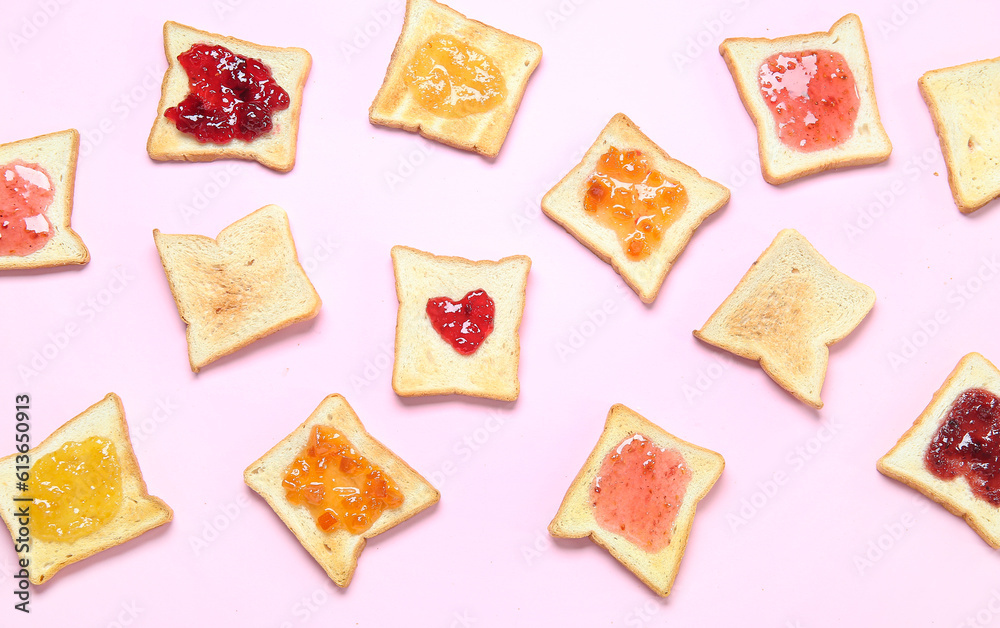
[243,395,440,587]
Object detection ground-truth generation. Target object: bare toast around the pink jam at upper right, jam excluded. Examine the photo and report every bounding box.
[719,13,892,185]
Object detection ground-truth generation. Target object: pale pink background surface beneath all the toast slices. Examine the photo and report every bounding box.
[0,0,1000,628]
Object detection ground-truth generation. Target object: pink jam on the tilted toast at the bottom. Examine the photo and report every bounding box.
[591,434,691,552]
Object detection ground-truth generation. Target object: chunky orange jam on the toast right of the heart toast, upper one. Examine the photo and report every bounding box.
[583,146,687,261]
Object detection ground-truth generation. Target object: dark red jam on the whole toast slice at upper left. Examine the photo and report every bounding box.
[163,44,289,144]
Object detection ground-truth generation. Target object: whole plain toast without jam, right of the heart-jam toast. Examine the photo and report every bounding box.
[694,229,875,408]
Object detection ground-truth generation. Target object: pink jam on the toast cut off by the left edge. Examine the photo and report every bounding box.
[0,160,55,256]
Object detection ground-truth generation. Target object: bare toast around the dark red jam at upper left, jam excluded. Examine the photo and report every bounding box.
[146,22,312,172]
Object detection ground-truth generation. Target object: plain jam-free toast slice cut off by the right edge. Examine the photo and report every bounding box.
[919,57,1000,214]
